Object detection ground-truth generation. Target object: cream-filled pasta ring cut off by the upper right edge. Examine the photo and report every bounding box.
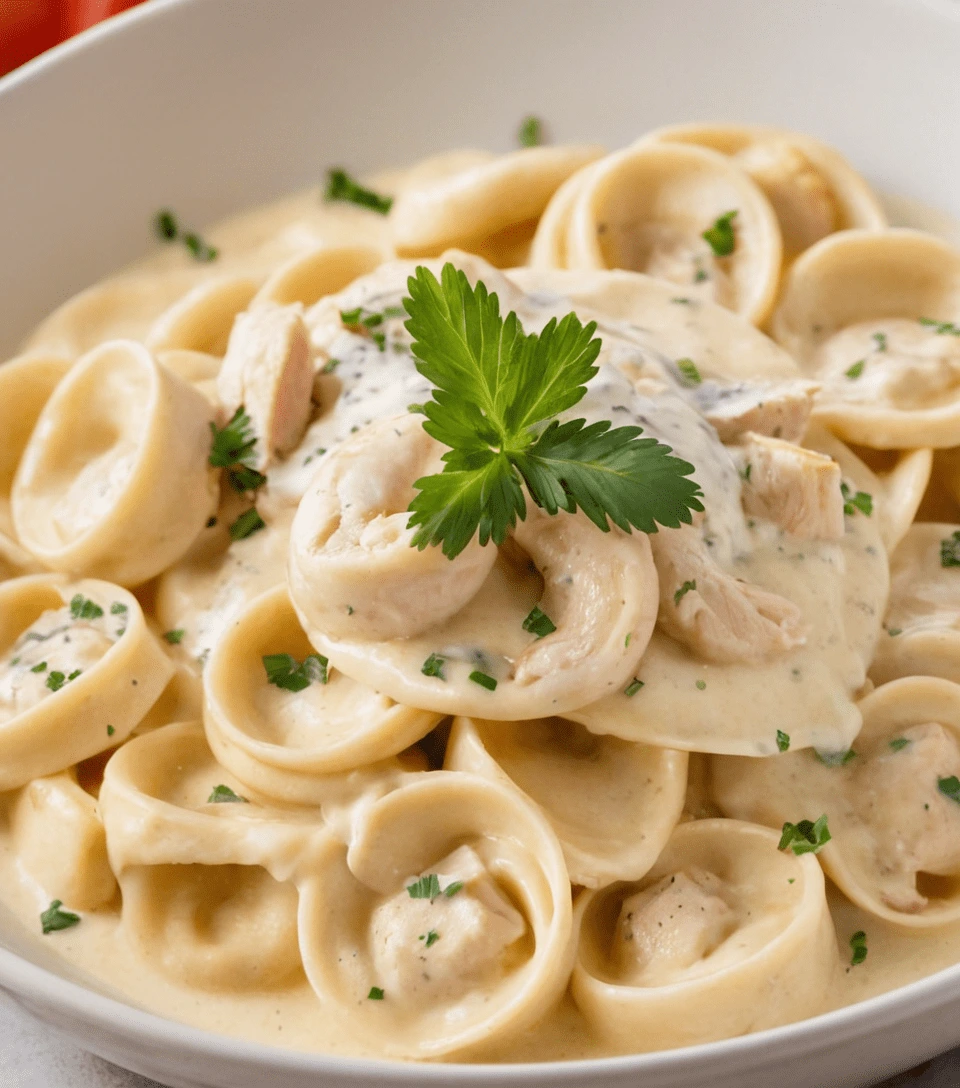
[772,228,960,449]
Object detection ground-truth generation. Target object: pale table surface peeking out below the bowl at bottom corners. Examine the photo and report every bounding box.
[0,991,960,1088]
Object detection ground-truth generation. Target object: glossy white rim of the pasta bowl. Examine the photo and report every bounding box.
[0,0,960,1086]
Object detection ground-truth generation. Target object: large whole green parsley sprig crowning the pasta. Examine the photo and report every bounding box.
[405,263,703,559]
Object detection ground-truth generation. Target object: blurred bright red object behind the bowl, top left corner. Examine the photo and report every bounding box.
[0,0,143,75]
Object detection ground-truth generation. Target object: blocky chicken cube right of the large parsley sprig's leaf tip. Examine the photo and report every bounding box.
[740,434,844,541]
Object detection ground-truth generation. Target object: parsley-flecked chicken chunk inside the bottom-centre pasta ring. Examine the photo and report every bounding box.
[371,846,527,1003]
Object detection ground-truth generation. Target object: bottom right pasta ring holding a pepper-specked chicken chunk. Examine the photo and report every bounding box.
[573,819,838,1051]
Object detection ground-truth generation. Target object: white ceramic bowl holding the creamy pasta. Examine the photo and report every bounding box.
[0,0,960,1088]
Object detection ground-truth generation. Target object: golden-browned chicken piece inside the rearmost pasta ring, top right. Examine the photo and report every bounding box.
[734,138,840,254]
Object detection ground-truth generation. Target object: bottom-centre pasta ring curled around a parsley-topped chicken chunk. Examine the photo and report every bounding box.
[300,771,574,1059]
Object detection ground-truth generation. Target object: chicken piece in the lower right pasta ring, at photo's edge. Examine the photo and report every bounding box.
[851,722,960,914]
